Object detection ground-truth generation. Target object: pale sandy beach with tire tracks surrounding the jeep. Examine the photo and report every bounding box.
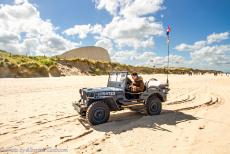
[0,75,230,154]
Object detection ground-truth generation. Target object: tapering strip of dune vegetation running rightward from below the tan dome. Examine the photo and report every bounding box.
[57,59,222,75]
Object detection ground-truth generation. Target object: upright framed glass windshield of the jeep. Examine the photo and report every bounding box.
[107,72,128,89]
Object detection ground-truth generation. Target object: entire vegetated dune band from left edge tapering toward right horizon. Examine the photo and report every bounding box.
[0,51,222,77]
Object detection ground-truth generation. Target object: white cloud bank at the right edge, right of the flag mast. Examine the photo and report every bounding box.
[175,32,230,70]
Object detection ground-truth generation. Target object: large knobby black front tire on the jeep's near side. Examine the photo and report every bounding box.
[86,101,110,125]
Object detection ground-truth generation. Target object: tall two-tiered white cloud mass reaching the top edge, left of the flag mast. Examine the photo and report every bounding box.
[91,0,164,49]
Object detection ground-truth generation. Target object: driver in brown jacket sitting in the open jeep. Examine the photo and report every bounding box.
[130,72,145,93]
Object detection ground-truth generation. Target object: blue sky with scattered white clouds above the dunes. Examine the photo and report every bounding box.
[0,0,230,72]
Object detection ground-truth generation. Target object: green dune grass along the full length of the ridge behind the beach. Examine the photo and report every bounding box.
[0,51,222,75]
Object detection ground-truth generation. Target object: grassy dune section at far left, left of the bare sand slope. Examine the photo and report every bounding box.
[0,51,51,77]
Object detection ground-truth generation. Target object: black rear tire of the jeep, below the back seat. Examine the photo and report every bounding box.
[146,96,162,115]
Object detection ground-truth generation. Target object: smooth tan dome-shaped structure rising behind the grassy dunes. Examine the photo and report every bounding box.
[58,46,111,62]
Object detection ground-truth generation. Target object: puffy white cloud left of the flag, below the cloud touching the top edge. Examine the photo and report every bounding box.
[102,17,163,49]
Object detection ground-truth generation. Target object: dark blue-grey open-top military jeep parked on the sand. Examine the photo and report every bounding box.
[73,71,169,125]
